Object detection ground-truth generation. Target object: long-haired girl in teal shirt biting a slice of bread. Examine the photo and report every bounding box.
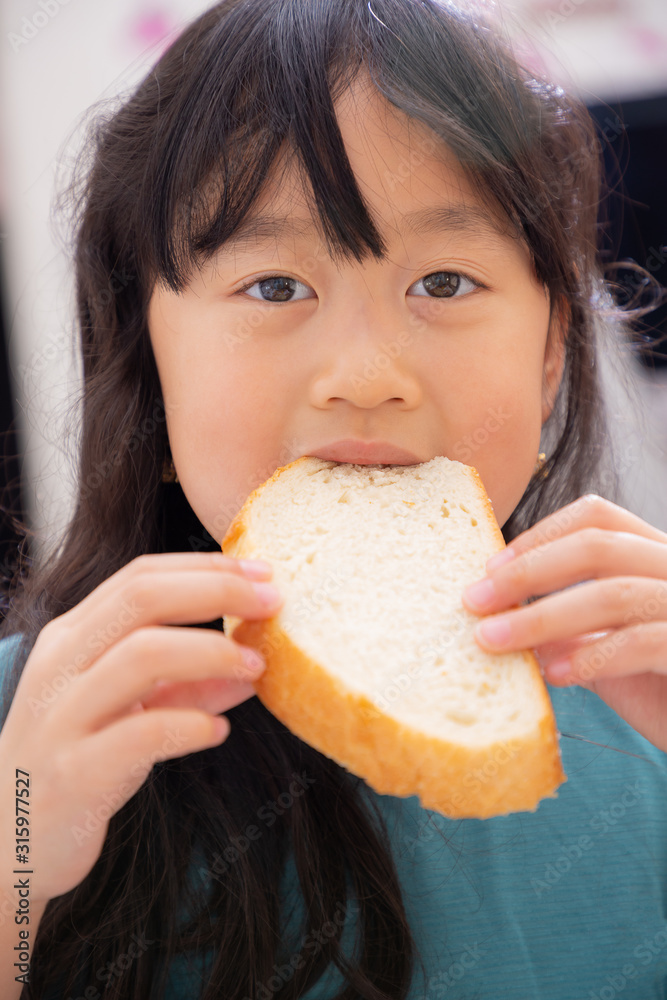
[0,0,667,1000]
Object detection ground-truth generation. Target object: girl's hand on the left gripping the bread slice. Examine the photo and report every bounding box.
[0,552,283,903]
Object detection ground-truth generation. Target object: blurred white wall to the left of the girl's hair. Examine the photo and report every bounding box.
[0,0,209,549]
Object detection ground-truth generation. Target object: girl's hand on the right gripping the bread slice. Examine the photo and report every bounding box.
[464,494,667,751]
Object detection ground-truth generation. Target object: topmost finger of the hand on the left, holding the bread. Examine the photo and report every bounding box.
[24,553,282,697]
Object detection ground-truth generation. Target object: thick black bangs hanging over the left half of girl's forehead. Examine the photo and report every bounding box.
[140,0,392,291]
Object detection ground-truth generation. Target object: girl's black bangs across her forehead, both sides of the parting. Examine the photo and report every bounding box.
[133,0,564,291]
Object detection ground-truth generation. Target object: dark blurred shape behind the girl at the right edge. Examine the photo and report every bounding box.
[589,95,667,371]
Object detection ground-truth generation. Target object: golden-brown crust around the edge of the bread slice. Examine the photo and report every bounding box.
[222,458,567,819]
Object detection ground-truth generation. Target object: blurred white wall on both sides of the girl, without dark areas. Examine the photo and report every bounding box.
[0,0,667,549]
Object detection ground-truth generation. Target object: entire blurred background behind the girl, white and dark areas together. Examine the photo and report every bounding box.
[0,0,667,584]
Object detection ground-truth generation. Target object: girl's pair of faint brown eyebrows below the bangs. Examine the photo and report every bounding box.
[219,205,508,251]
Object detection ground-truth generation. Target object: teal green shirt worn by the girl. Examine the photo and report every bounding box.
[0,637,667,1000]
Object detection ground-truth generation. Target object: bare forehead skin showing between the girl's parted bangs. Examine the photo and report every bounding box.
[225,82,517,253]
